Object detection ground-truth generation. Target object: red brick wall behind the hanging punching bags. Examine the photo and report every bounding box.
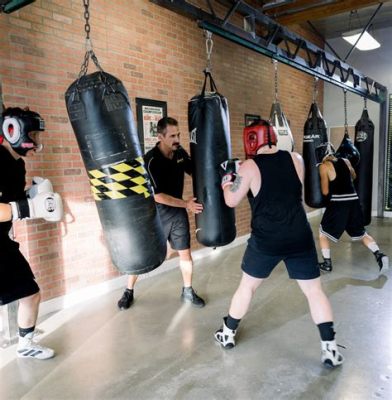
[0,0,324,299]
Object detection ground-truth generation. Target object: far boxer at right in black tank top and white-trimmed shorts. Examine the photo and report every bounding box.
[316,143,389,274]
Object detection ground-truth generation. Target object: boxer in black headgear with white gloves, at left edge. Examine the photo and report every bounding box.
[0,108,63,360]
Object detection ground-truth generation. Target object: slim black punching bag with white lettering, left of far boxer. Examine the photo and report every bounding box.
[302,102,328,208]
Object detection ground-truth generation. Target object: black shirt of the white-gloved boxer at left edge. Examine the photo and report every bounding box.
[0,145,26,241]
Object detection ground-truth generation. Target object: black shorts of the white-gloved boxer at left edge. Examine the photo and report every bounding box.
[0,238,39,305]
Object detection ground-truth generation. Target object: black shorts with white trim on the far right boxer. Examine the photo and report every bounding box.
[320,200,366,242]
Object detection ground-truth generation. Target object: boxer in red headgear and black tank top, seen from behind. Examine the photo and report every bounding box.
[215,121,343,367]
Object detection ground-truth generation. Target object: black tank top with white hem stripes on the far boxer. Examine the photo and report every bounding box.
[329,158,358,201]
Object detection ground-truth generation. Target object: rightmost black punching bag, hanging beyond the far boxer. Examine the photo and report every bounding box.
[354,108,374,225]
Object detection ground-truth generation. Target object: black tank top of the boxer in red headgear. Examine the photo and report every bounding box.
[249,150,314,255]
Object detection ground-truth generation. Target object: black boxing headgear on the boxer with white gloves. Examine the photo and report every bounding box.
[2,107,45,156]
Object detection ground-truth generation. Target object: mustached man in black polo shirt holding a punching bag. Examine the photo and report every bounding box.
[118,117,205,310]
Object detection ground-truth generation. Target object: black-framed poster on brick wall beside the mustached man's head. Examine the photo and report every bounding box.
[136,97,167,154]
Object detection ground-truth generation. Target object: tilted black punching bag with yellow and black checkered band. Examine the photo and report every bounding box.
[65,71,166,275]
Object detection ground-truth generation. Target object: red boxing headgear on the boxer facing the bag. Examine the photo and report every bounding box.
[243,119,278,158]
